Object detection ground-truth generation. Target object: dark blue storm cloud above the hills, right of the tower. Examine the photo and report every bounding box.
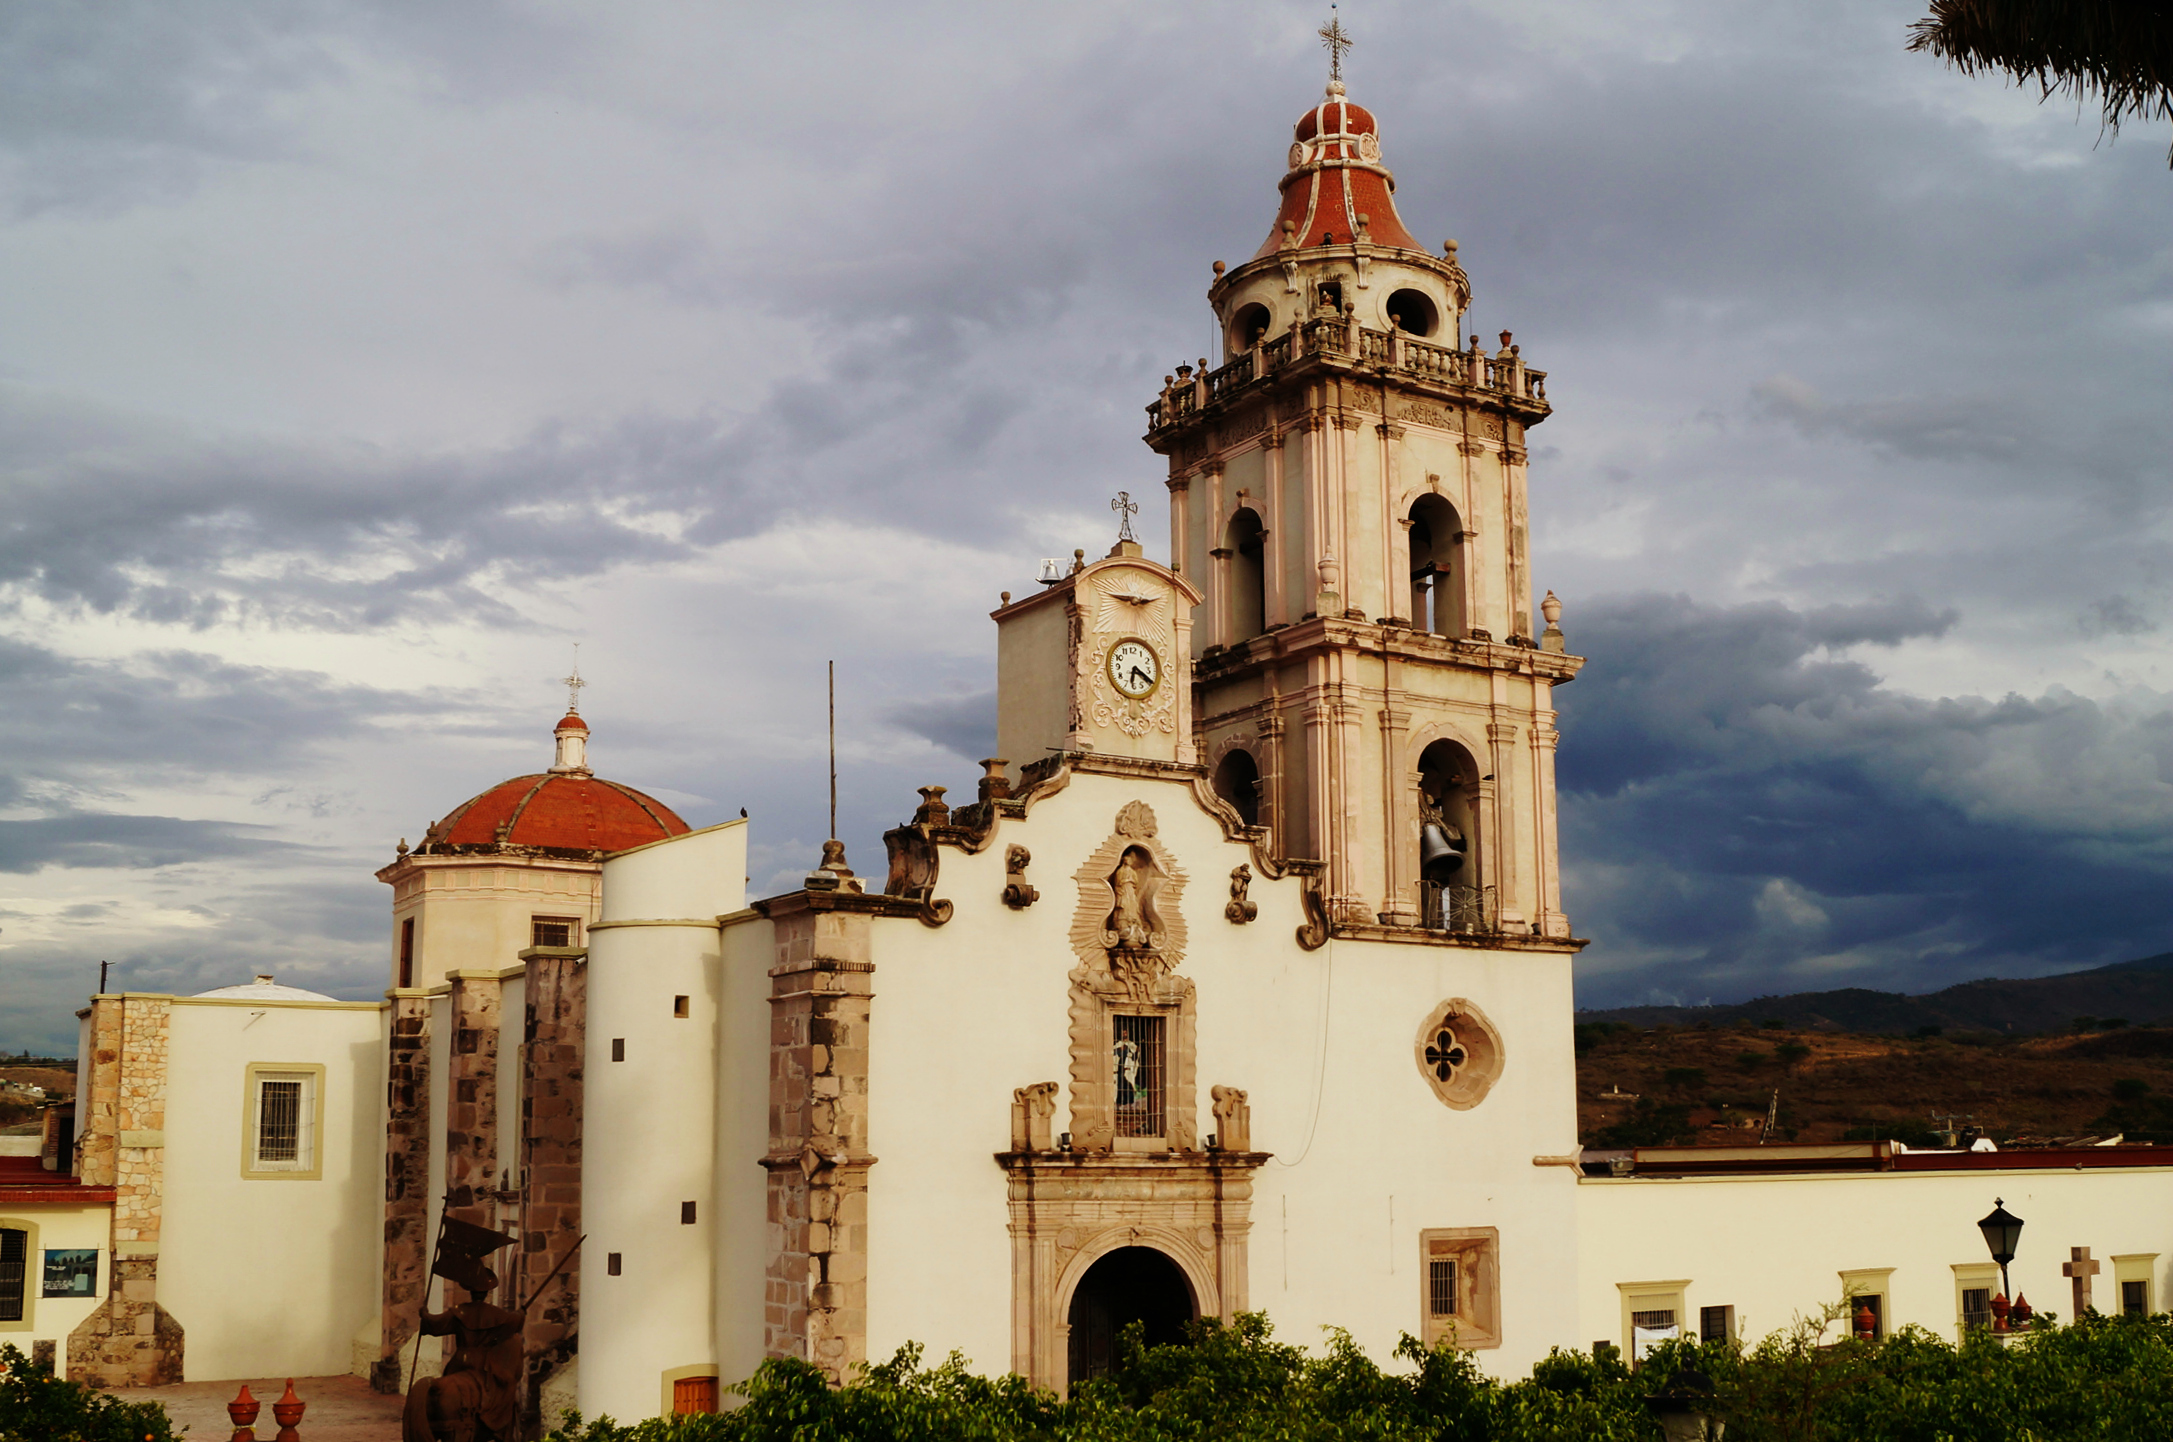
[1558,595,2173,1005]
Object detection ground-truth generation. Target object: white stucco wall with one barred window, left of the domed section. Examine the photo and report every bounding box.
[159,997,385,1381]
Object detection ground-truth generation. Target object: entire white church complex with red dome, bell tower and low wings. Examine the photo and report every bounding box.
[12,59,2173,1422]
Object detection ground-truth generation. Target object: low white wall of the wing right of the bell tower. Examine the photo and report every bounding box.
[1575,1168,2173,1346]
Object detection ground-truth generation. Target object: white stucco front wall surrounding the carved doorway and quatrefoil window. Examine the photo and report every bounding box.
[867,775,1578,1373]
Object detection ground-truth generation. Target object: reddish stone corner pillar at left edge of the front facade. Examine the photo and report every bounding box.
[763,895,876,1383]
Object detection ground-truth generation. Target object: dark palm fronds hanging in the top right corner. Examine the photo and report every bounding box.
[1908,0,2173,163]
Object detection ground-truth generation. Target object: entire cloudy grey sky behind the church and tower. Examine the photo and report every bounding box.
[0,0,2173,1047]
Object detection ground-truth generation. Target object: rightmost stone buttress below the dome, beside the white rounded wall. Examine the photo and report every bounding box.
[517,947,589,1435]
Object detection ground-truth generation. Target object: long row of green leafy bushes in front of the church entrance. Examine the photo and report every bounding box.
[548,1303,2173,1442]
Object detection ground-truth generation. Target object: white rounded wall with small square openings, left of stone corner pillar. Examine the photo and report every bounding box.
[580,821,748,1420]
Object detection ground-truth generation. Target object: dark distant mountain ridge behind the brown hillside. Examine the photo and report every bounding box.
[1578,951,2173,1036]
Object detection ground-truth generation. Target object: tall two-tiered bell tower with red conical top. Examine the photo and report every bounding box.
[1145,61,1582,938]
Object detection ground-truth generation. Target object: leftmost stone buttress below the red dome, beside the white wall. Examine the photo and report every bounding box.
[369,995,430,1394]
